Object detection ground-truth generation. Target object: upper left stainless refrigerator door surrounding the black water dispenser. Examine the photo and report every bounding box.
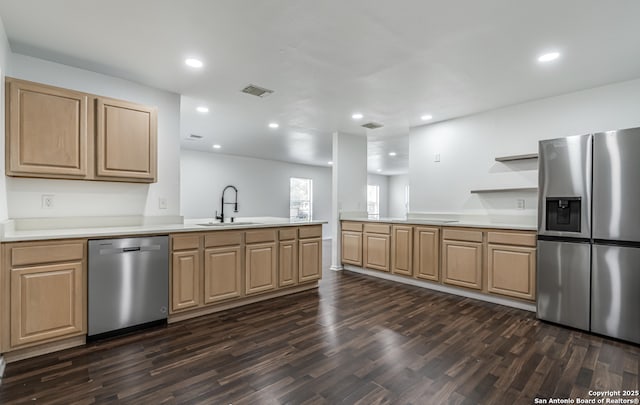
[538,135,593,238]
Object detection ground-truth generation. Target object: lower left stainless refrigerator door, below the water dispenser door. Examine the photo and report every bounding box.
[537,240,591,330]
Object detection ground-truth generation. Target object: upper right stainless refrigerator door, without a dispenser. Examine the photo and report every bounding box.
[593,128,640,242]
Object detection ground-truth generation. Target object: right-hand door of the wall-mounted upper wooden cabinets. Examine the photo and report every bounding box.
[96,97,157,182]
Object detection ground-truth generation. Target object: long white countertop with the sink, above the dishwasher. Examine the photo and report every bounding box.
[0,217,327,242]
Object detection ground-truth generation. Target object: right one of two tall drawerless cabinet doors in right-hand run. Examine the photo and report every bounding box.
[413,227,440,281]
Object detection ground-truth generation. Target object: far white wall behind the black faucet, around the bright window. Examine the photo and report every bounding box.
[180,150,331,237]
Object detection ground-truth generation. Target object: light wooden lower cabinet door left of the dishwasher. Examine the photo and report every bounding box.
[11,262,85,347]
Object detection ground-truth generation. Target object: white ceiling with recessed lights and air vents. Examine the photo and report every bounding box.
[0,0,640,174]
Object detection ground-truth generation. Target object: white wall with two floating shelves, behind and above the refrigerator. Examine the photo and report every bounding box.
[409,79,640,215]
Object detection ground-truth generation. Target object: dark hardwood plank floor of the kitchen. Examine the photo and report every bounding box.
[0,244,640,404]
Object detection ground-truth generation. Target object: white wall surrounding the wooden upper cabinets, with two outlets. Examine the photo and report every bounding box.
[5,54,180,218]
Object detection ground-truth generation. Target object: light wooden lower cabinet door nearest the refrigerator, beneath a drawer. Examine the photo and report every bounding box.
[487,244,536,300]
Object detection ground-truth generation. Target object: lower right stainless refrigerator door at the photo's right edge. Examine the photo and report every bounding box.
[591,245,640,343]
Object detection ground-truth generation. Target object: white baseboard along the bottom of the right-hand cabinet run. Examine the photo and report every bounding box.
[344,264,536,312]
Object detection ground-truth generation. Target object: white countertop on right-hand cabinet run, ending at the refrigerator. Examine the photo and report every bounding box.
[340,217,538,231]
